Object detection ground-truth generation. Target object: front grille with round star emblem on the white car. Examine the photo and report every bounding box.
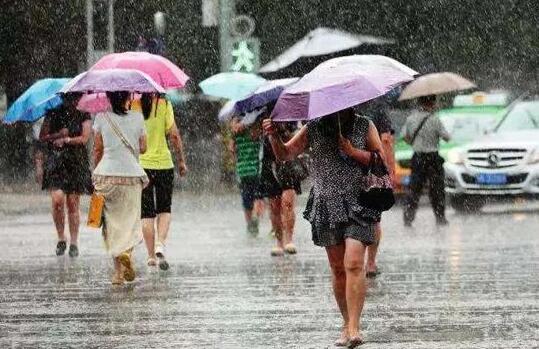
[468,148,526,169]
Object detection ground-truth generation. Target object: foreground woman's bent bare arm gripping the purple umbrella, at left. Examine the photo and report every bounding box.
[262,119,308,161]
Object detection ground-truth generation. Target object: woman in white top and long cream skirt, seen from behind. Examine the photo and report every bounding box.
[93,91,148,285]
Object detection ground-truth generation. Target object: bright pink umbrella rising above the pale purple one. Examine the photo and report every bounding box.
[90,52,189,89]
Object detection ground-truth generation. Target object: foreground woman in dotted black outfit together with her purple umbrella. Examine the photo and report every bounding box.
[263,59,413,348]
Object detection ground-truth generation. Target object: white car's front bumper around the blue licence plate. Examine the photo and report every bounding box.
[444,163,539,196]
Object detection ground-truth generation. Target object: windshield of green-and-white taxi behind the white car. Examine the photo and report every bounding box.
[440,113,499,143]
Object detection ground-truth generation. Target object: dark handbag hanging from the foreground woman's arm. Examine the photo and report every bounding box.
[360,152,395,212]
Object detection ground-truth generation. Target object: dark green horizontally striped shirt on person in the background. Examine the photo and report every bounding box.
[236,133,260,179]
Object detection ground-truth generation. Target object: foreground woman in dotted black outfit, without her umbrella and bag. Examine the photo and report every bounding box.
[264,109,383,348]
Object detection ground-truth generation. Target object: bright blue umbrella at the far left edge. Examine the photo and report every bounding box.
[3,79,70,124]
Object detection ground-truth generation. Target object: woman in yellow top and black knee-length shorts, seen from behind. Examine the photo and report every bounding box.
[135,93,187,270]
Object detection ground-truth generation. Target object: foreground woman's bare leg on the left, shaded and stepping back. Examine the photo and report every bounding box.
[326,244,349,342]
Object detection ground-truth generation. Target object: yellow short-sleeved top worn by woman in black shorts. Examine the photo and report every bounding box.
[131,98,174,170]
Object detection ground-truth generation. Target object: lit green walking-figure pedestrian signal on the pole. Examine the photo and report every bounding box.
[230,38,260,73]
